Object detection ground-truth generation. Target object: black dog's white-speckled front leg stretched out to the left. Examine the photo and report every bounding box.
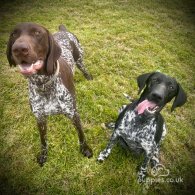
[97,131,118,162]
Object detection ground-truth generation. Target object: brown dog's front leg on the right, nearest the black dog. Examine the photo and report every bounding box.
[73,113,93,158]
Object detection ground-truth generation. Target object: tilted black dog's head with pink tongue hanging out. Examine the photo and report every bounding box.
[136,72,187,114]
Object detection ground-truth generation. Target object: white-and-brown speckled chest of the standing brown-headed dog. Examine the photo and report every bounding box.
[29,75,74,117]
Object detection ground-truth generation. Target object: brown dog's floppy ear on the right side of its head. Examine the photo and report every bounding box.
[46,32,61,74]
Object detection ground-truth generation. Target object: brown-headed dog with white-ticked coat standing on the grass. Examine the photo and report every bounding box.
[7,23,92,166]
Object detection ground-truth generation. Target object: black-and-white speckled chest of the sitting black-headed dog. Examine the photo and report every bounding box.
[118,110,156,150]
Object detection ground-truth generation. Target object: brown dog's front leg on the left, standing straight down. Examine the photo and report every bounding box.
[37,117,47,166]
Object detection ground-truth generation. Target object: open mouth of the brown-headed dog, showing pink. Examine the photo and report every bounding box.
[18,60,44,75]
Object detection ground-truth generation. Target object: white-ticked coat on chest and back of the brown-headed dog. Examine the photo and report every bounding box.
[29,31,83,120]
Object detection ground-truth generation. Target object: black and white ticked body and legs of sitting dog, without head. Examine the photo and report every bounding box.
[98,101,167,181]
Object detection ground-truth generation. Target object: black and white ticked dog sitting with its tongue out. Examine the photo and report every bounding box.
[98,72,187,181]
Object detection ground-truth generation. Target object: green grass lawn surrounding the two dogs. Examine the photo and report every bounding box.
[0,0,195,195]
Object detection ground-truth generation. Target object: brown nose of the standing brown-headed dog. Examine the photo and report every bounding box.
[12,42,29,56]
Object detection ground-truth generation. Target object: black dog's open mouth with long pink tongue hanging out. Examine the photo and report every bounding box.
[136,99,159,114]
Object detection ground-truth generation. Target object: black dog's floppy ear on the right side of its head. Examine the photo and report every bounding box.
[171,83,187,112]
